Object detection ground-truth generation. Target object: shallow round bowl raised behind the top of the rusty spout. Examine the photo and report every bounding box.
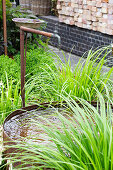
[12,18,45,29]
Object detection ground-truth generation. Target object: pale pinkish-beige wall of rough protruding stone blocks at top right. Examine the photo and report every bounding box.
[57,0,113,35]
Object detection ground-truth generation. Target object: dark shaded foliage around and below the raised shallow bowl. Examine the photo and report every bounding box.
[0,6,37,55]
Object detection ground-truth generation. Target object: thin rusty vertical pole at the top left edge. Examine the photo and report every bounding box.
[2,0,7,55]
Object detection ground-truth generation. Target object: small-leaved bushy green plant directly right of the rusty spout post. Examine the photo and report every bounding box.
[15,40,54,80]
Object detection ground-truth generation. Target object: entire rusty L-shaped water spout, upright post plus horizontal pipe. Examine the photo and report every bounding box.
[20,26,60,107]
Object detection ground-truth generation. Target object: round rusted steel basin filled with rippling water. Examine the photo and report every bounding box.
[3,102,66,168]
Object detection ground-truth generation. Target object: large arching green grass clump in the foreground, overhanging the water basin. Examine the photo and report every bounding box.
[2,91,113,170]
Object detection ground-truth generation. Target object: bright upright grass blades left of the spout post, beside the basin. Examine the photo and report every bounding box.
[0,73,21,124]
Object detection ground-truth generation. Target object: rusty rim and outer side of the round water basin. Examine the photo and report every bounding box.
[3,103,59,170]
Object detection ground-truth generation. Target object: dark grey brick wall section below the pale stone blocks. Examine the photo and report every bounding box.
[40,16,113,66]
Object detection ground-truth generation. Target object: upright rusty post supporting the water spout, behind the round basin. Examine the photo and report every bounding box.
[20,29,25,107]
